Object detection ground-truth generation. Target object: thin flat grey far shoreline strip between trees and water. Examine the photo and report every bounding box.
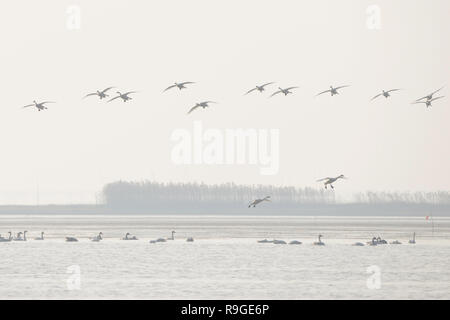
[0,202,450,217]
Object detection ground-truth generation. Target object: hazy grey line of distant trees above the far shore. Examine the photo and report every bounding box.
[102,181,450,209]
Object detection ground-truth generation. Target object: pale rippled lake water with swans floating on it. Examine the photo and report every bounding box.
[0,215,450,299]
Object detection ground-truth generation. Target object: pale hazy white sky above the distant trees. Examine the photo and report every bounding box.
[0,0,450,204]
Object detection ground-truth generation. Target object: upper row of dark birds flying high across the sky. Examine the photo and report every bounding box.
[24,81,444,114]
